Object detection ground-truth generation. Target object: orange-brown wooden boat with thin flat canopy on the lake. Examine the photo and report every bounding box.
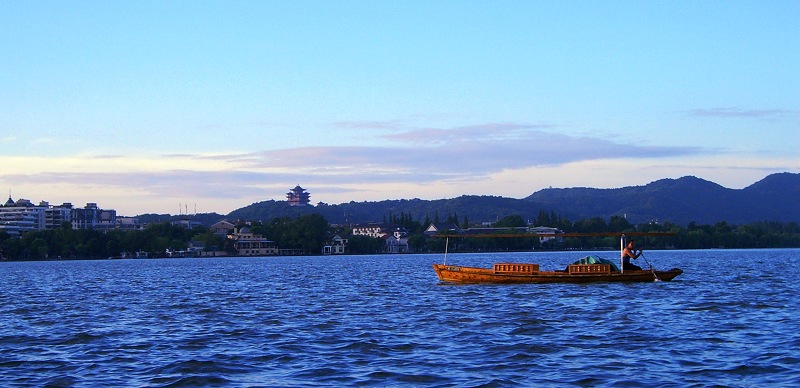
[433,233,683,283]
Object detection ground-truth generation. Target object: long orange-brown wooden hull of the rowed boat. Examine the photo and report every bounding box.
[433,264,683,283]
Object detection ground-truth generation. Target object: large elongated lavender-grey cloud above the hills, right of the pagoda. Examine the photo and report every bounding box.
[197,124,713,177]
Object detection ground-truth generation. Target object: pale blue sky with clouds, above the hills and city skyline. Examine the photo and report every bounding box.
[0,0,800,216]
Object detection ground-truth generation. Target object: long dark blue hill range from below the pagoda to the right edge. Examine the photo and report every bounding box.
[217,173,800,225]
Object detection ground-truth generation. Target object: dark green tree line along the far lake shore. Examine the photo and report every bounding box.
[0,214,800,261]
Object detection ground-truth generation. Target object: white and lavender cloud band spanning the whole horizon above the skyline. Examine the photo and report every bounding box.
[0,124,800,215]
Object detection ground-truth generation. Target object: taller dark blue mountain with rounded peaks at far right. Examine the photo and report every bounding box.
[525,173,800,225]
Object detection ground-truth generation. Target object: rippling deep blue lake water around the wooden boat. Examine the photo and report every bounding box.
[0,249,800,387]
